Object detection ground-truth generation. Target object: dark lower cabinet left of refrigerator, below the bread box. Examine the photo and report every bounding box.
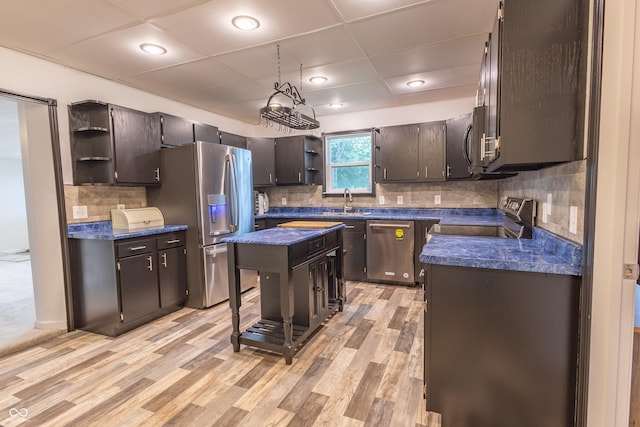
[69,231,187,336]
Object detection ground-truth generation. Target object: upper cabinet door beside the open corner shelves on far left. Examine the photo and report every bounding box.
[111,106,160,184]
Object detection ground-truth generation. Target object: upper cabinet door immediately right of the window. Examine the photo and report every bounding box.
[379,125,418,182]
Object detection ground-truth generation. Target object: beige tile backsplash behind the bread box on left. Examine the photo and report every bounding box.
[64,185,147,224]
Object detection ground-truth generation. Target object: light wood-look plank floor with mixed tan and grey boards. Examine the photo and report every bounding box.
[0,282,440,427]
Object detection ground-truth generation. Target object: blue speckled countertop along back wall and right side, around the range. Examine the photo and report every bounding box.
[256,207,582,276]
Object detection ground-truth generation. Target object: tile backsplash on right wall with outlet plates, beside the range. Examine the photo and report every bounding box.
[498,160,587,244]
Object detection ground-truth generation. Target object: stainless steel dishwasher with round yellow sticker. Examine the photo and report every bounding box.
[367,221,414,284]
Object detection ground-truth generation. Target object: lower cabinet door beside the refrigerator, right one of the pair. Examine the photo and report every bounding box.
[158,247,187,307]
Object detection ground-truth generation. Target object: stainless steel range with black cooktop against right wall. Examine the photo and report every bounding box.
[429,197,536,239]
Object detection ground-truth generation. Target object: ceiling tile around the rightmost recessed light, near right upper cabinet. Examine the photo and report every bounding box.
[387,64,480,94]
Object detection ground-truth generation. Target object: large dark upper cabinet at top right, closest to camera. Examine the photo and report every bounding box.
[474,0,588,172]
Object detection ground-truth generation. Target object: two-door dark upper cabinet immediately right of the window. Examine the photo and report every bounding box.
[376,122,446,183]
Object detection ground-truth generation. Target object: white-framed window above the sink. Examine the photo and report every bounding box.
[324,130,373,195]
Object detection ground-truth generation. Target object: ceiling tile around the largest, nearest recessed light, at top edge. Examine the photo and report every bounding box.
[152,0,340,55]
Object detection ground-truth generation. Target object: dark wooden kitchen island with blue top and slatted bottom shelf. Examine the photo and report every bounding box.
[223,223,345,364]
